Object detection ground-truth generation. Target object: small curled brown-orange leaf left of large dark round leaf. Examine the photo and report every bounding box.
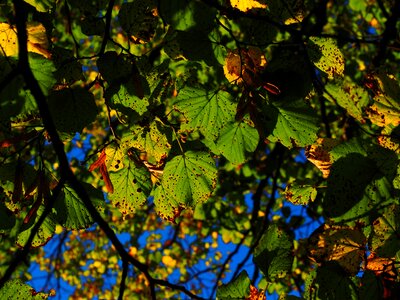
[306,138,339,178]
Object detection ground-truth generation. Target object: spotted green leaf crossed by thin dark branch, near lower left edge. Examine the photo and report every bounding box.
[16,205,56,248]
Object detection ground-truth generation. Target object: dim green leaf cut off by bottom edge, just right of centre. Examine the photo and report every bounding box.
[217,271,251,300]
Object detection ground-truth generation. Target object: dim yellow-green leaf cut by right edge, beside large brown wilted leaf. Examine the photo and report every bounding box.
[368,204,400,257]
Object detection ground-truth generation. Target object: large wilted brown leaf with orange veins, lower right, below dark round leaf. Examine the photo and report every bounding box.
[308,224,366,275]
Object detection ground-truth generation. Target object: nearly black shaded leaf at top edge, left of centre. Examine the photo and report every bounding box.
[118,0,159,42]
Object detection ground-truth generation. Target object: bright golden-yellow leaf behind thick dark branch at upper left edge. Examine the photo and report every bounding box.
[0,23,51,58]
